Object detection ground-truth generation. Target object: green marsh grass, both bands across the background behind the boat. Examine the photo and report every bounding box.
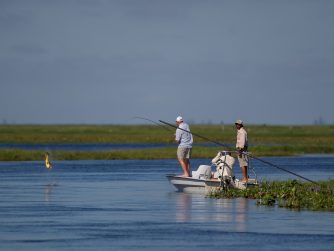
[0,125,334,161]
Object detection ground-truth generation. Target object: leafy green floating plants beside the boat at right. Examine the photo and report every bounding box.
[208,180,334,211]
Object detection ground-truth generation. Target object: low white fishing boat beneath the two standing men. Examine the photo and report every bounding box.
[166,151,258,193]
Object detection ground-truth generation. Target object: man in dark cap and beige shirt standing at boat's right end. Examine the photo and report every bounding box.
[235,119,248,182]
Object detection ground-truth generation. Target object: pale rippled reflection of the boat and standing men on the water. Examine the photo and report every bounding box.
[176,193,249,231]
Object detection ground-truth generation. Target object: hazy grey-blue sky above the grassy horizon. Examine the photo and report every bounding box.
[0,0,334,125]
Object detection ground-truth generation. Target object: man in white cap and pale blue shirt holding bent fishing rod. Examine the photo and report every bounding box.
[175,116,193,177]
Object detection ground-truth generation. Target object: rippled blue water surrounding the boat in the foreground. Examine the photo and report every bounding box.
[0,156,334,250]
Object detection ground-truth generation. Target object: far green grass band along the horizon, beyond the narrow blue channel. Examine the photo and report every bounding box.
[0,124,334,145]
